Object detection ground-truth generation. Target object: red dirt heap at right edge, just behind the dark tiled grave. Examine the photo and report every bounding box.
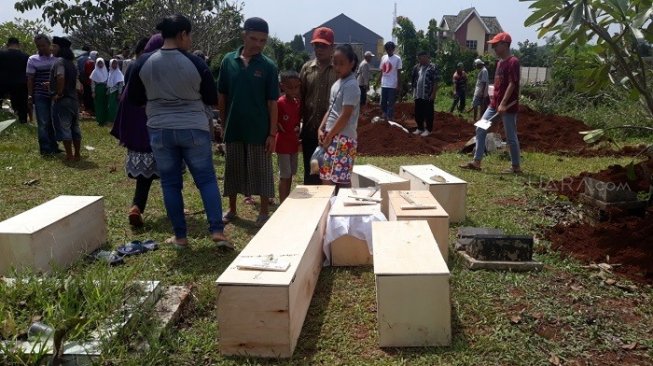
[542,159,653,201]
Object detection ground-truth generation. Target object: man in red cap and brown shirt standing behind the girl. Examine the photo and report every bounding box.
[299,27,338,185]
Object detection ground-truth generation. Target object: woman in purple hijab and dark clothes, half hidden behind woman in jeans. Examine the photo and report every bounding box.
[111,34,163,227]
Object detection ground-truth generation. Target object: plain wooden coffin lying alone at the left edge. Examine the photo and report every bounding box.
[0,196,107,275]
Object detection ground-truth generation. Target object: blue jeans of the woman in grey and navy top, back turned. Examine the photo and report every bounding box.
[148,128,224,239]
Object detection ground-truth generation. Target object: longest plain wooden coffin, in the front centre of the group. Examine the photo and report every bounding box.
[217,186,335,358]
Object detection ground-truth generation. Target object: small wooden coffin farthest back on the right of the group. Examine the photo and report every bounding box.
[399,164,467,223]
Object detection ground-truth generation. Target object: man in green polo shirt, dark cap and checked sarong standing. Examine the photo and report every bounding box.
[218,18,279,226]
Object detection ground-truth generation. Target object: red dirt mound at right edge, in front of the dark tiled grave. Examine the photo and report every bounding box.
[547,213,653,284]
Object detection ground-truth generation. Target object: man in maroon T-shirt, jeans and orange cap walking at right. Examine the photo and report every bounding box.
[460,33,521,174]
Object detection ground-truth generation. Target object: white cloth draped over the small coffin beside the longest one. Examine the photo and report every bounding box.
[322,197,388,266]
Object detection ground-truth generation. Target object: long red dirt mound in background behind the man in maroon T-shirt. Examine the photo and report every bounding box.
[358,103,640,156]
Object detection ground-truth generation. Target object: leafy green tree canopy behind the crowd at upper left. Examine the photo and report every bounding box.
[15,0,243,61]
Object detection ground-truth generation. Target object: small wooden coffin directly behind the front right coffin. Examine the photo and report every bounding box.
[388,191,449,262]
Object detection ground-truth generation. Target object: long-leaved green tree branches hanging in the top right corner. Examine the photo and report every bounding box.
[520,0,653,119]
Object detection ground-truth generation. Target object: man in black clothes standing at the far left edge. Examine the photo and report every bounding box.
[0,37,29,123]
